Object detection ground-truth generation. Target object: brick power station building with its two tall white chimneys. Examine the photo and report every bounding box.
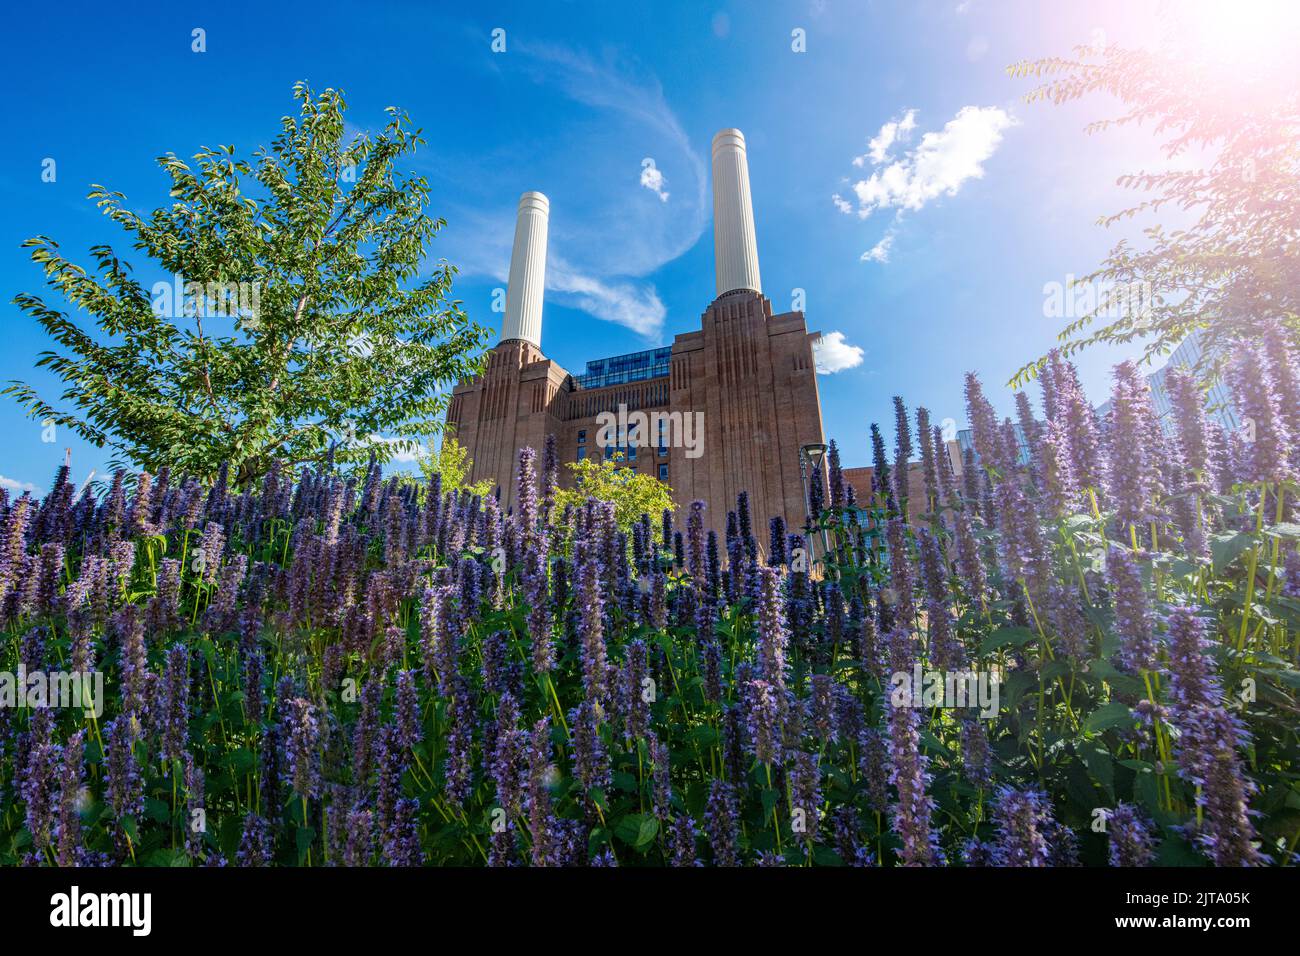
[447,129,824,536]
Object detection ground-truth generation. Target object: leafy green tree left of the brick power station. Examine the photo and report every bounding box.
[5,83,488,483]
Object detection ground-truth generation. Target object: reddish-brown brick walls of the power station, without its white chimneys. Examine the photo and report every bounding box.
[447,290,824,541]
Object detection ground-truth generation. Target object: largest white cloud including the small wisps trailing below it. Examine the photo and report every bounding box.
[831,107,1017,263]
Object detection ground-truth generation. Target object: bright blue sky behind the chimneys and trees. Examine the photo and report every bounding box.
[0,0,1237,490]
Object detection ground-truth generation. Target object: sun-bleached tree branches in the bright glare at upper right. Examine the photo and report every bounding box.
[1008,11,1300,386]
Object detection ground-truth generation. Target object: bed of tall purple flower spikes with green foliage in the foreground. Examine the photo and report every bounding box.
[0,333,1300,866]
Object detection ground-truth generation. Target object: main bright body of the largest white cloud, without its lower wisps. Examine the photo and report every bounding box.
[853,107,1017,219]
